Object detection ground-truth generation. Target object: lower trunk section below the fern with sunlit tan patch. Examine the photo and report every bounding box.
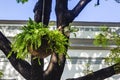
[44,53,66,80]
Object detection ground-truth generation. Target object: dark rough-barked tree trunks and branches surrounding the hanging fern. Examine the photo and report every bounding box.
[0,0,120,80]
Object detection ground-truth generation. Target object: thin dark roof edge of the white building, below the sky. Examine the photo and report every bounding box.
[0,20,120,27]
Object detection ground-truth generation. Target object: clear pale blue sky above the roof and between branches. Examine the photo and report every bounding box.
[0,0,120,22]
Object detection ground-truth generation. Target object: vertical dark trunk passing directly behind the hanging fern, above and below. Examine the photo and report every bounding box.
[31,0,52,80]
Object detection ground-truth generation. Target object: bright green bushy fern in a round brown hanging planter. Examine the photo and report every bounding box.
[8,19,69,59]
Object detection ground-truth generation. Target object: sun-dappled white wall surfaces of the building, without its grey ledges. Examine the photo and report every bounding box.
[0,24,120,80]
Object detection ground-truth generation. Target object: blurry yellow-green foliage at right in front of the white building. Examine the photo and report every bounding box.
[94,26,120,65]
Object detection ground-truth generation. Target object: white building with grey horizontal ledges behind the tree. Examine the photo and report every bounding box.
[0,20,120,80]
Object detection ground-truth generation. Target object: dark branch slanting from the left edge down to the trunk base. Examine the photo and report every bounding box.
[0,32,31,80]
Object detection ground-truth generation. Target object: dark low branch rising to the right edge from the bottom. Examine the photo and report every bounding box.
[67,63,120,80]
